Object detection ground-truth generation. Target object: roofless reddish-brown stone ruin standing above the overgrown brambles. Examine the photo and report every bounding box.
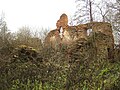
[45,14,114,58]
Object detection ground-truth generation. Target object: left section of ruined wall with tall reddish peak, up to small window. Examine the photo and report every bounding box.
[45,14,87,48]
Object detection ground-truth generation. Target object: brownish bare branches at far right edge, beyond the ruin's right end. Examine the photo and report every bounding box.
[106,0,120,43]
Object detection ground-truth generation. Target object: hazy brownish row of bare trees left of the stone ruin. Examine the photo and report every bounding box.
[0,14,49,49]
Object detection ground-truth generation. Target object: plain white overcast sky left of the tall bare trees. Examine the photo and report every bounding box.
[0,0,76,31]
